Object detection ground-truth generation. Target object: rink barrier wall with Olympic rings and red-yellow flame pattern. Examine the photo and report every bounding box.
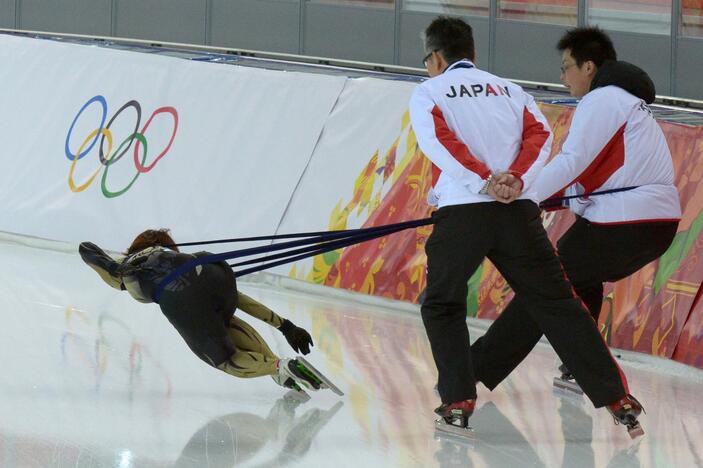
[0,36,703,367]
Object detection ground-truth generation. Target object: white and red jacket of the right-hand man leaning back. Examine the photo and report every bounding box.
[537,85,681,224]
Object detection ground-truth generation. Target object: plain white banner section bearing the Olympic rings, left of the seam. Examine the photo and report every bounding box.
[0,35,346,250]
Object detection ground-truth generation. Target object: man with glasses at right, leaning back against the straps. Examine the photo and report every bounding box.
[471,27,681,394]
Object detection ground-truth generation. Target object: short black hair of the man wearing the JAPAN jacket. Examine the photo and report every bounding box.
[424,16,476,65]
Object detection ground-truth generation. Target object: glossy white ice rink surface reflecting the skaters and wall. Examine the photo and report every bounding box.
[0,242,703,468]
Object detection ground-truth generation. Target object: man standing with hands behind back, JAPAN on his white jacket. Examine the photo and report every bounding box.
[410,17,636,427]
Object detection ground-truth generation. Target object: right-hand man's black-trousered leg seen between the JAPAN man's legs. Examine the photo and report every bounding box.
[471,295,542,390]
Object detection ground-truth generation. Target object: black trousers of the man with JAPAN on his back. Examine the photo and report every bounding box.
[422,200,627,407]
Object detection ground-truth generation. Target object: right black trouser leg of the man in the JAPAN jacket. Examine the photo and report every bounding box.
[490,201,627,407]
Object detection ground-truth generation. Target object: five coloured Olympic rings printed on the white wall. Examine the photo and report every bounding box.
[65,95,178,198]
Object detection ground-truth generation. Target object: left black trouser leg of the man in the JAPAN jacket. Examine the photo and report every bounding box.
[421,207,492,403]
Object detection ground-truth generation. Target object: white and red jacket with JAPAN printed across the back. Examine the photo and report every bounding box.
[410,60,552,208]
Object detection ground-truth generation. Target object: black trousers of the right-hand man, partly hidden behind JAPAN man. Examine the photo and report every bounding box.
[471,218,678,398]
